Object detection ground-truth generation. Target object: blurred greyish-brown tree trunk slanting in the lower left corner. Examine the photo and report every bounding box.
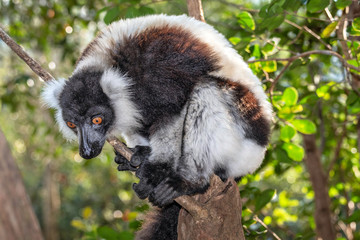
[0,131,43,240]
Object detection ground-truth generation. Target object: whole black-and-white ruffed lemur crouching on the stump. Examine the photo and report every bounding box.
[43,15,272,240]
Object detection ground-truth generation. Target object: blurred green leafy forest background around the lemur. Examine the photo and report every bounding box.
[0,0,360,239]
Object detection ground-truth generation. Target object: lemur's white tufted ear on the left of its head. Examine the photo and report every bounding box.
[41,79,66,109]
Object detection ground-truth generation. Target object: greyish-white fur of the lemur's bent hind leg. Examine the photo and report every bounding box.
[180,84,266,180]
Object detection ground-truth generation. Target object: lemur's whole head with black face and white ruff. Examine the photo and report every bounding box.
[42,68,141,159]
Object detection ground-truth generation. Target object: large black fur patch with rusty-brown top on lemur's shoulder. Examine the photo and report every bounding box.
[111,27,217,131]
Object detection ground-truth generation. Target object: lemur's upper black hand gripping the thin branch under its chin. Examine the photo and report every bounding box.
[115,146,151,171]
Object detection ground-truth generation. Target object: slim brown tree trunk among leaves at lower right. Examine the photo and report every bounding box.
[303,135,336,240]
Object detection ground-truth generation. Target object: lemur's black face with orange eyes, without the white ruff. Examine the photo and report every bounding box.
[60,72,114,159]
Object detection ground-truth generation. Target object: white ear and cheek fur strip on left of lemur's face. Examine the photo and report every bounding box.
[41,79,77,140]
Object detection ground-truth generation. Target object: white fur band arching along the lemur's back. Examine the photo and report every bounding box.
[75,15,272,123]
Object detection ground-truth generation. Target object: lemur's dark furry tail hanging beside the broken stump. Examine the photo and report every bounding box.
[135,202,181,240]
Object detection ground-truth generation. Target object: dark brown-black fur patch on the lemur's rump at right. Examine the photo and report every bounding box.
[218,79,270,146]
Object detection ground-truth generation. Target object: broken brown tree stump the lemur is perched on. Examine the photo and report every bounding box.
[178,176,245,240]
